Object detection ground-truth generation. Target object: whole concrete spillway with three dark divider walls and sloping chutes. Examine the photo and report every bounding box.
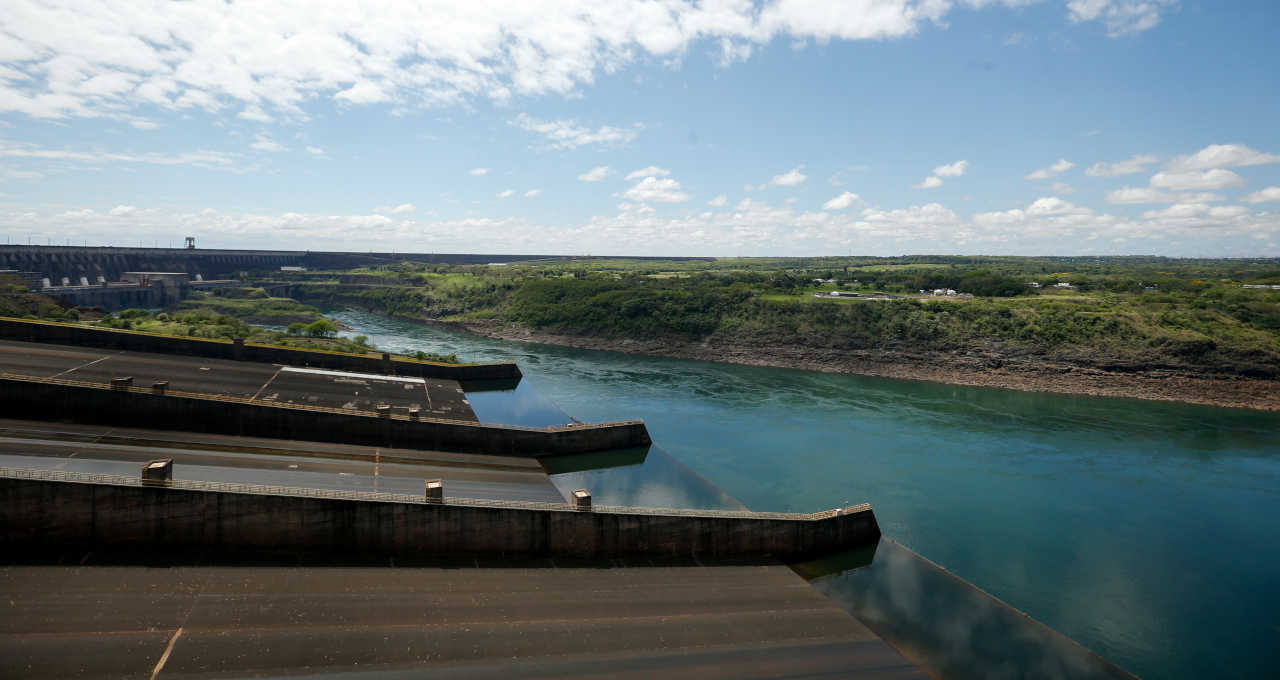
[0,320,1128,677]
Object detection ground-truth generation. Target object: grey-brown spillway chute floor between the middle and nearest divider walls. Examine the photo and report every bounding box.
[0,420,564,503]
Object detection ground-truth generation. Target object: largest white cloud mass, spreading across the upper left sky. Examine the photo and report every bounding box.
[0,0,1171,120]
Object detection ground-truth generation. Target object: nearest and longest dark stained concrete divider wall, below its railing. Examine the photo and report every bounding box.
[0,478,879,560]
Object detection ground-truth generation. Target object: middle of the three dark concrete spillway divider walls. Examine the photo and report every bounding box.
[0,376,652,457]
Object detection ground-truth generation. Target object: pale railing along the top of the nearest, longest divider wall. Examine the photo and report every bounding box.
[0,467,872,521]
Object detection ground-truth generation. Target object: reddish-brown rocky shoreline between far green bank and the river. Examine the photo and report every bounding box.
[442,319,1280,411]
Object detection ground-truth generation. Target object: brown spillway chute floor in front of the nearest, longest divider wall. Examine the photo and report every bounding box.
[0,562,928,679]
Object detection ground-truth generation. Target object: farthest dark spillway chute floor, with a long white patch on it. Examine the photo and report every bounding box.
[0,341,477,423]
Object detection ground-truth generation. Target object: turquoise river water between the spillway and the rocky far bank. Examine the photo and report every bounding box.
[335,311,1280,677]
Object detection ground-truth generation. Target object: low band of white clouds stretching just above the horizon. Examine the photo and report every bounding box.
[12,195,1280,255]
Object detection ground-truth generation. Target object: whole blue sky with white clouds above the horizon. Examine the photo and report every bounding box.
[0,0,1280,256]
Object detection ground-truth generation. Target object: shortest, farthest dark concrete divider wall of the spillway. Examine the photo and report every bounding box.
[0,318,521,382]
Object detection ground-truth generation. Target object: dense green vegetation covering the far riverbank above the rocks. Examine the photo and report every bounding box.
[288,256,1280,376]
